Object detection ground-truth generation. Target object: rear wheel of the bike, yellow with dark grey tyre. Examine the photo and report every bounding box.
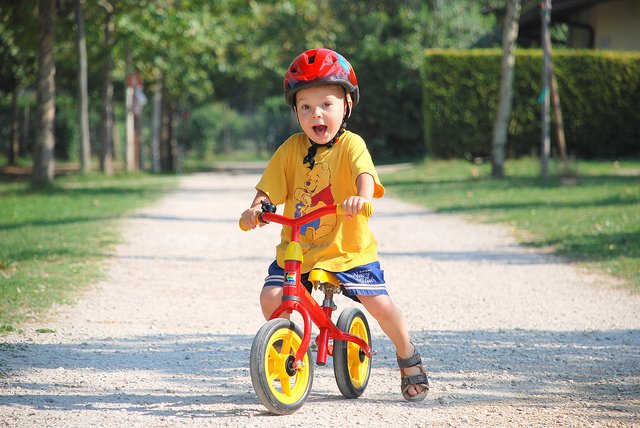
[333,308,371,398]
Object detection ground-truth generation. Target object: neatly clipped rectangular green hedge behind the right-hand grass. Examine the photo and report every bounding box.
[423,49,640,159]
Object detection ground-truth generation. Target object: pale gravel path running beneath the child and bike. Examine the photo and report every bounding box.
[0,173,640,427]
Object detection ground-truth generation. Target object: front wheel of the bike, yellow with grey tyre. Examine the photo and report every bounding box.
[249,318,314,415]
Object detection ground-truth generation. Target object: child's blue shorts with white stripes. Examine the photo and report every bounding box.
[264,261,389,302]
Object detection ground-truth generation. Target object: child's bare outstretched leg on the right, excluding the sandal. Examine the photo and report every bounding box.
[358,294,424,396]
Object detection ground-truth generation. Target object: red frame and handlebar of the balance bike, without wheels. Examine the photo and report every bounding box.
[259,205,371,370]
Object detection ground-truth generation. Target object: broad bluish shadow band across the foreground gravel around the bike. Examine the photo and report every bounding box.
[0,329,640,422]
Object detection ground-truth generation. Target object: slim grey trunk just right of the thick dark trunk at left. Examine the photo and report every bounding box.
[75,0,91,174]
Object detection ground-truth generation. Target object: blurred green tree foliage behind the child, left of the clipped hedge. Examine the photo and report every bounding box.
[0,0,503,165]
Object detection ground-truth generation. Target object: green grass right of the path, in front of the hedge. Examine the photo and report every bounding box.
[382,159,640,291]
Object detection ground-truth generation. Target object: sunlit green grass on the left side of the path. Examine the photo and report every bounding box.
[0,173,177,333]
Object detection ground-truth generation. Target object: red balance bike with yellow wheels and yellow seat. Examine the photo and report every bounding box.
[240,202,373,415]
